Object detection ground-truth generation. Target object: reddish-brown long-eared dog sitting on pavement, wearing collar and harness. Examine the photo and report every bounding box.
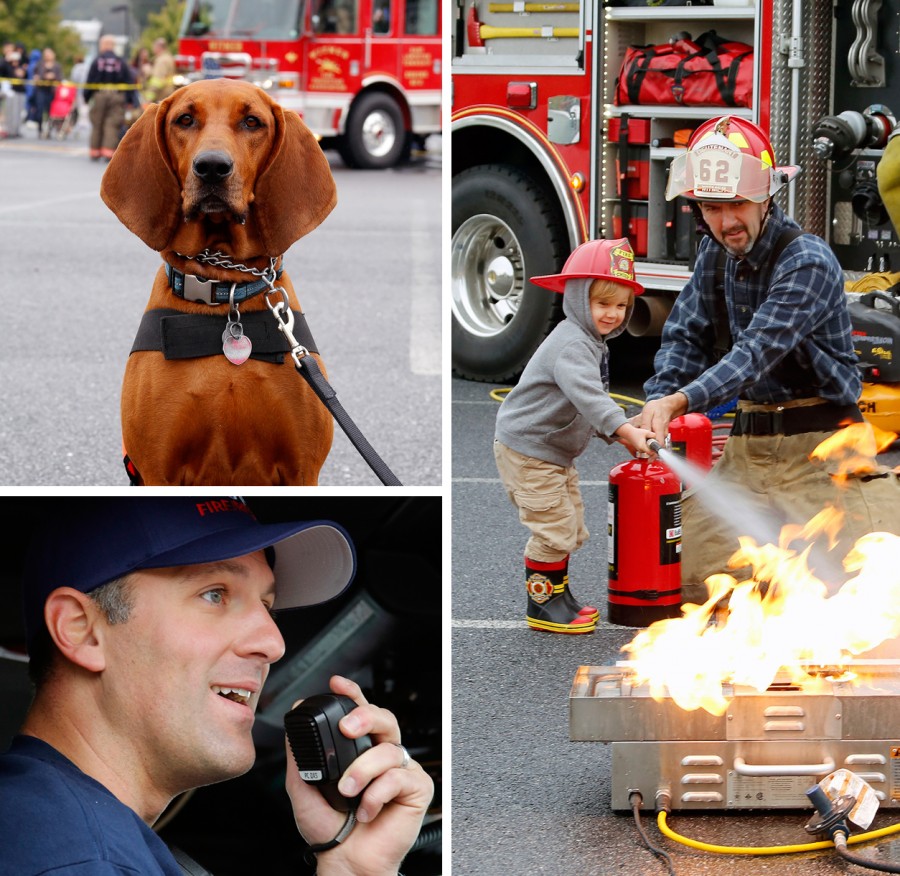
[101,79,337,486]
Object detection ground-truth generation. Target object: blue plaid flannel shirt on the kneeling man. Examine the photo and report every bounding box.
[644,205,862,411]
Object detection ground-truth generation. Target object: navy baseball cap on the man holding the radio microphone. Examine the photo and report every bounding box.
[23,497,356,647]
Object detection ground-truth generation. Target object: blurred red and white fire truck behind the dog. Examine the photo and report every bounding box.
[176,0,441,168]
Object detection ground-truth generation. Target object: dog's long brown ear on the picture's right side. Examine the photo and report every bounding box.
[253,105,337,255]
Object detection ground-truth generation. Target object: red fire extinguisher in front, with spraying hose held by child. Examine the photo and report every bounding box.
[607,457,681,627]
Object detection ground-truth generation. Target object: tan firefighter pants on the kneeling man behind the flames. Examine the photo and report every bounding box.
[681,432,900,602]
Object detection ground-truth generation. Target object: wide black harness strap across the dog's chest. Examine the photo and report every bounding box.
[131,307,318,365]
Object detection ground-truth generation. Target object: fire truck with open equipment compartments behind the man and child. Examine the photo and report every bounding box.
[451,0,900,382]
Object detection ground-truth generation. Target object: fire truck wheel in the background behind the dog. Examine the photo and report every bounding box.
[338,91,409,168]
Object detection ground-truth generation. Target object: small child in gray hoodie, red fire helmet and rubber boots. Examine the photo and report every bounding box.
[494,238,653,633]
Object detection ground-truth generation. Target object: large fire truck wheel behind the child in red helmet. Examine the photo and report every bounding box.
[451,165,567,382]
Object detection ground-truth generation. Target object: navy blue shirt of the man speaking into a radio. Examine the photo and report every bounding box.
[0,736,182,876]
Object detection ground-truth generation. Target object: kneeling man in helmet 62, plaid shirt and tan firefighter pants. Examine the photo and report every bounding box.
[634,116,900,602]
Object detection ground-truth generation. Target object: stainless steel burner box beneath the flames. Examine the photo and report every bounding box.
[569,661,900,810]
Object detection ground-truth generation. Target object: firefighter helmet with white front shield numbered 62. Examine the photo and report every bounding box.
[666,116,800,204]
